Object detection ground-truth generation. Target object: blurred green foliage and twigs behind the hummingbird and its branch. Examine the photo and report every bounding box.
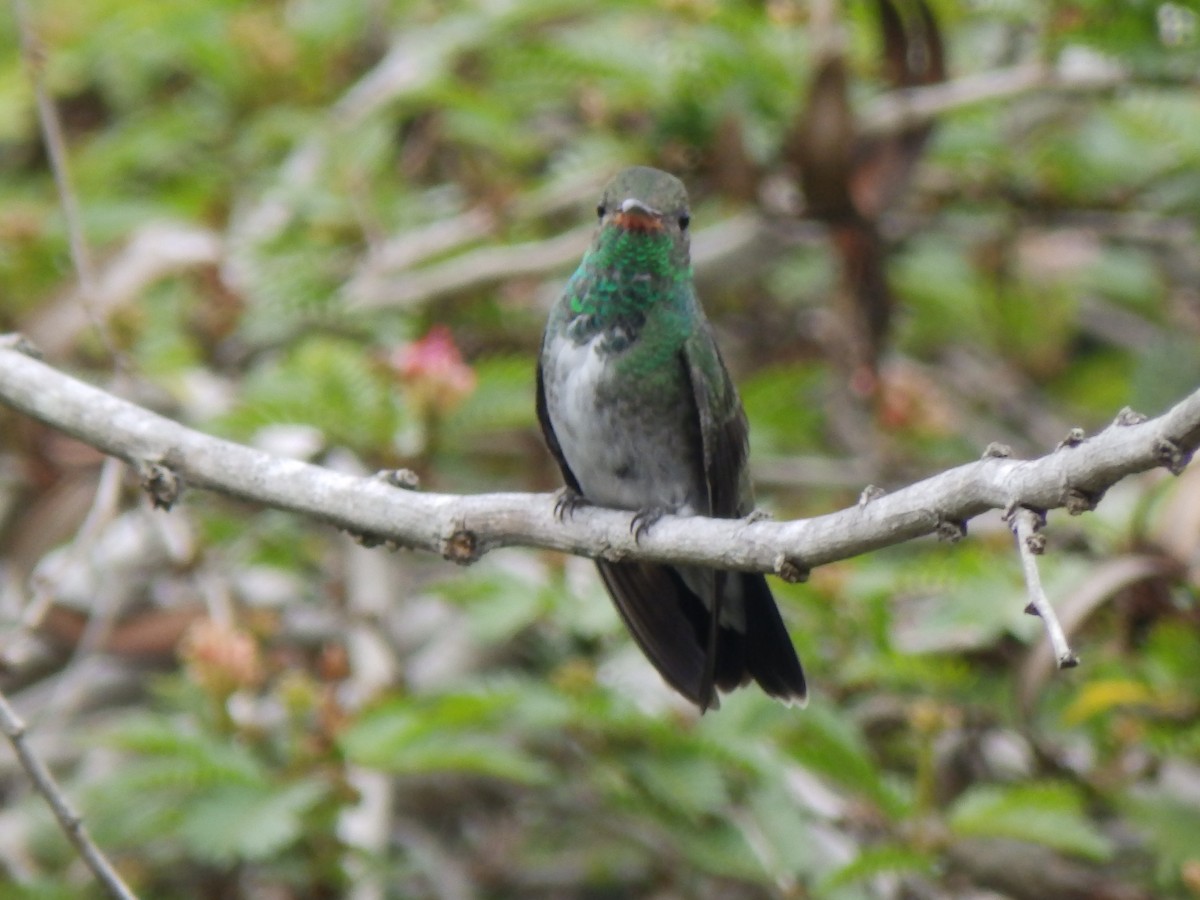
[0,0,1200,900]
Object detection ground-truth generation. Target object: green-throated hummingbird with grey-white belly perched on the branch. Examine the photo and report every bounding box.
[538,166,806,712]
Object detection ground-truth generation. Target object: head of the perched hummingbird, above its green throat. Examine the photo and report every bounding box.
[596,166,691,264]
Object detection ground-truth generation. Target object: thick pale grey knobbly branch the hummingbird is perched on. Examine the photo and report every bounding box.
[0,336,1200,581]
